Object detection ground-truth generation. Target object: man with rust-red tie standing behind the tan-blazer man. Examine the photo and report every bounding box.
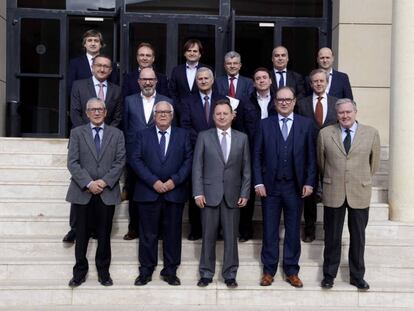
[296,68,337,243]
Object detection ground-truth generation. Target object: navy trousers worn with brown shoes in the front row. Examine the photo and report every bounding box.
[261,180,303,276]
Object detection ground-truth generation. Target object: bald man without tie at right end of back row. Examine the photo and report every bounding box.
[316,47,354,99]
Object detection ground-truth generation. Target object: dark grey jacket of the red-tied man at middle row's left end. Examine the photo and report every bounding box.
[70,77,122,127]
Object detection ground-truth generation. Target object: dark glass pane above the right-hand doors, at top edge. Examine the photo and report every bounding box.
[231,0,323,17]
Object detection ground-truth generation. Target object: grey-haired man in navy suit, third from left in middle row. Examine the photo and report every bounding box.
[181,67,226,241]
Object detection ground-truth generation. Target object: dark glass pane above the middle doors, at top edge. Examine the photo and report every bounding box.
[125,0,220,15]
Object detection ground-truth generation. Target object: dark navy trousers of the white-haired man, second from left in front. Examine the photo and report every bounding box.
[138,196,184,276]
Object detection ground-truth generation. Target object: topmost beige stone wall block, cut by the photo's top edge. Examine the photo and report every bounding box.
[333,0,392,24]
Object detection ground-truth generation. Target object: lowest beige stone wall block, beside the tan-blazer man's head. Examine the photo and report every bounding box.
[351,86,390,146]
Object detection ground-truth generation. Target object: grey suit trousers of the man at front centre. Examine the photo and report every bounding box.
[199,201,240,280]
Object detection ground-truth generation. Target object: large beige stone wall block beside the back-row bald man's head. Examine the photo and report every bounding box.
[337,24,391,87]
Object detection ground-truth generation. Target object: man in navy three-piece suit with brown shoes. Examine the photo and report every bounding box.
[253,87,316,287]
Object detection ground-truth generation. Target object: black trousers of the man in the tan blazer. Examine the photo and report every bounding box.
[323,204,369,280]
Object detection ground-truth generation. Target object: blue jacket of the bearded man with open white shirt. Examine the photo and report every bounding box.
[122,93,172,156]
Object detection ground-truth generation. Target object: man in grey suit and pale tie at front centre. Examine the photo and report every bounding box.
[192,99,251,288]
